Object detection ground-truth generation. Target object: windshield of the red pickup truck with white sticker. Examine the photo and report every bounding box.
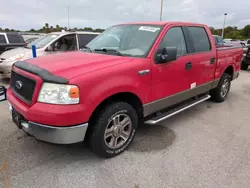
[84,25,162,57]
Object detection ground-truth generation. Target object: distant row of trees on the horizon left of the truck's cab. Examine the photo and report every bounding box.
[0,23,104,33]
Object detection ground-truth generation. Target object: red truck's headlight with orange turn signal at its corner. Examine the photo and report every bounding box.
[38,83,79,104]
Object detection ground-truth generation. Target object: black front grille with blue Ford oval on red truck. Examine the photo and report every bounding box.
[10,71,36,104]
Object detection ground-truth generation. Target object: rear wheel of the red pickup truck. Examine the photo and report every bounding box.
[210,73,231,102]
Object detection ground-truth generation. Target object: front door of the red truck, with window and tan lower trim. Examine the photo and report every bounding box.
[150,27,195,113]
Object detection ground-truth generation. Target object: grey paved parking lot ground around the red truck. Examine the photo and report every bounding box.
[0,71,250,188]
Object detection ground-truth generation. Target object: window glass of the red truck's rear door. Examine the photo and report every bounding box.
[188,26,212,53]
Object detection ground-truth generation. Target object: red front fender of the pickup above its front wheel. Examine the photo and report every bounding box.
[70,62,151,122]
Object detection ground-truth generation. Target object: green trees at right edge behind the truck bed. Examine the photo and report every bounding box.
[210,25,250,40]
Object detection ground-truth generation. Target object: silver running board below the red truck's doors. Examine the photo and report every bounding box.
[145,95,211,124]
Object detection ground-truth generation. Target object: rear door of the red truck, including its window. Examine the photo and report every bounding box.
[187,26,216,89]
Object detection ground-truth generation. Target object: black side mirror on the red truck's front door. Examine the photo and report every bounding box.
[155,47,177,64]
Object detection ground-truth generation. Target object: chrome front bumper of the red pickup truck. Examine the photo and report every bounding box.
[21,121,88,144]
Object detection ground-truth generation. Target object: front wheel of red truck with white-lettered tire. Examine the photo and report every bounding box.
[89,102,138,158]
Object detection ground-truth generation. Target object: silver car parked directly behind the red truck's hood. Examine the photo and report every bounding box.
[0,32,100,78]
